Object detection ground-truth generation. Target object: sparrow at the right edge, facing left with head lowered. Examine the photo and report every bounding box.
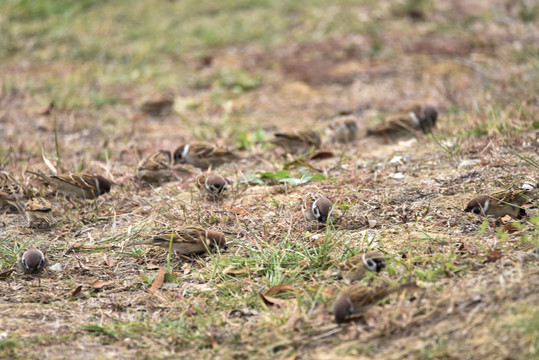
[464,189,536,219]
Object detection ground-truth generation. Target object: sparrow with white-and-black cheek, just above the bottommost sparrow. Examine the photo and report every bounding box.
[337,251,386,284]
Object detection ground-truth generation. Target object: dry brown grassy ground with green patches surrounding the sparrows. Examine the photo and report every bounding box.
[0,0,539,359]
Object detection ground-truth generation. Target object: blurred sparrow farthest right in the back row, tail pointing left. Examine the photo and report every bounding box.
[367,105,438,136]
